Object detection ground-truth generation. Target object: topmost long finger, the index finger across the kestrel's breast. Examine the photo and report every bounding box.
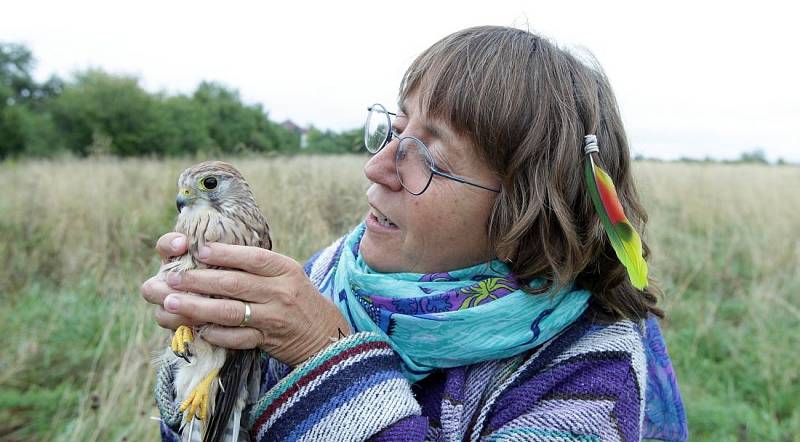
[197,243,302,276]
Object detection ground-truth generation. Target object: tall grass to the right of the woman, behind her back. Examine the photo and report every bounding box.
[637,164,800,441]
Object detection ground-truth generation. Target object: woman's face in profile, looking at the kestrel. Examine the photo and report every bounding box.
[360,92,500,273]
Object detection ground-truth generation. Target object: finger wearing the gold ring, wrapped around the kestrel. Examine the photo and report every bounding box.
[164,293,259,327]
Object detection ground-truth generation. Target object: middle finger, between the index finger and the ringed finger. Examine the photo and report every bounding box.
[166,269,287,303]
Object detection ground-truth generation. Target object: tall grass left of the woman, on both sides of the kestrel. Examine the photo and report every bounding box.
[0,157,366,441]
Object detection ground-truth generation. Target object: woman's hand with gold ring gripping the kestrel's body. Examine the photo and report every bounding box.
[141,232,350,365]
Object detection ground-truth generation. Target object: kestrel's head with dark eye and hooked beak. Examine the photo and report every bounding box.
[175,161,253,213]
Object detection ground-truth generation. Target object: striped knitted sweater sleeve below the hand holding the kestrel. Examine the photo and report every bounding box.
[250,332,427,441]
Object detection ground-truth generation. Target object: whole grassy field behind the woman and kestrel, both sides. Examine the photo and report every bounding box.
[0,156,800,441]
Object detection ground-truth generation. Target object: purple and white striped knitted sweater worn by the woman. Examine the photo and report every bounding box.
[159,256,687,441]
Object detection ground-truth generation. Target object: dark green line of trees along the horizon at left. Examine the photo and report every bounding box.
[0,43,361,159]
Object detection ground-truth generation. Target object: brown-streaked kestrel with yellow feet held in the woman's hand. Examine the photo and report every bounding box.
[160,161,272,441]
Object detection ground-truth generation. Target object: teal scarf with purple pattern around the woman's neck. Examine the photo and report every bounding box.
[311,224,589,382]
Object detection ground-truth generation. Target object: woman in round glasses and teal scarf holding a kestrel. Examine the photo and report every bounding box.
[142,27,686,440]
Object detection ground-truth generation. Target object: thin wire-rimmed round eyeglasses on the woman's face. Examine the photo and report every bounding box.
[364,103,500,195]
